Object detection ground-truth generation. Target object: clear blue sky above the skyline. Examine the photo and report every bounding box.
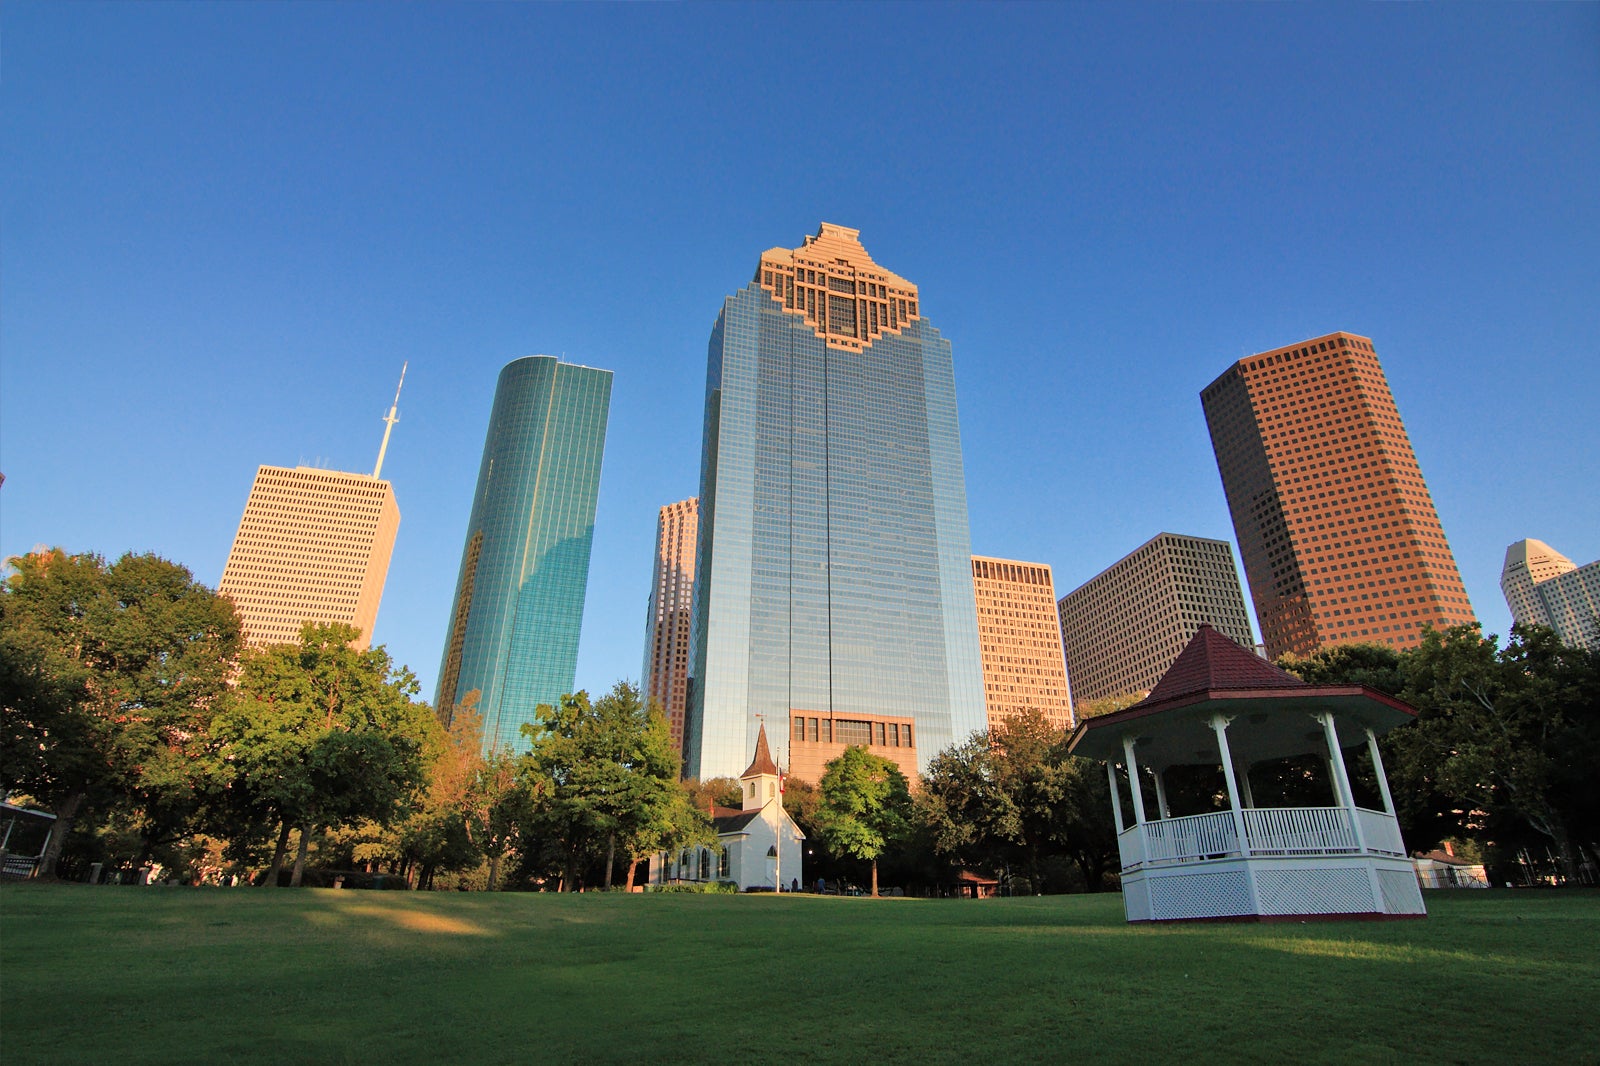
[0,0,1600,698]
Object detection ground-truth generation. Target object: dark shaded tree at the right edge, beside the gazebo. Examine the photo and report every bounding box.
[1397,623,1600,882]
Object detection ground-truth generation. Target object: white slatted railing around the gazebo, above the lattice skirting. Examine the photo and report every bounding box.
[1117,807,1405,869]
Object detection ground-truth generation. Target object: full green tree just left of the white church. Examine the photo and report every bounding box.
[523,682,717,888]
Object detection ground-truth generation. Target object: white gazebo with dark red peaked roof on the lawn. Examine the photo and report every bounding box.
[1072,626,1426,922]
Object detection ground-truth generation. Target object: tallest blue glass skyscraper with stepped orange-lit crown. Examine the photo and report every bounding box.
[683,222,986,779]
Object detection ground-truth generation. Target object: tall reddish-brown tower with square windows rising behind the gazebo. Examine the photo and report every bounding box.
[1200,331,1475,659]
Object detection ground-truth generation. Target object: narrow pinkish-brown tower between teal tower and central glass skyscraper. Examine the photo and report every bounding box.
[640,496,699,752]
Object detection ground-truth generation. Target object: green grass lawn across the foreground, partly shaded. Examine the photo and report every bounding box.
[0,884,1600,1066]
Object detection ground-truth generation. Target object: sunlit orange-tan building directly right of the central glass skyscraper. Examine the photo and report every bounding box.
[973,555,1074,728]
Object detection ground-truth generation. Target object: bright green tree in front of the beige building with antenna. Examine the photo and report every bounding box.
[211,623,438,885]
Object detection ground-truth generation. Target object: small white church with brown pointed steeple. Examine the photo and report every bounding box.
[650,725,805,892]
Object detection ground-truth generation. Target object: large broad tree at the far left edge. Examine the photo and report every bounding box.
[0,549,240,877]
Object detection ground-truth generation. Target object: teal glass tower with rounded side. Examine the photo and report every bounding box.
[434,355,611,749]
